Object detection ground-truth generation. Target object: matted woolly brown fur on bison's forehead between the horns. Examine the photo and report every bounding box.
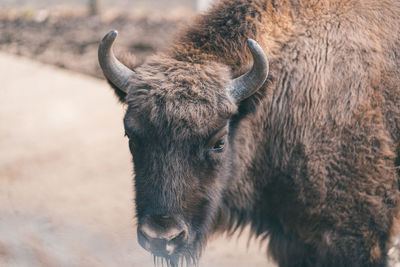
[127,55,237,137]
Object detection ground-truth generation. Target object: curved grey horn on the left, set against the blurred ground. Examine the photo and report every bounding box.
[98,30,133,93]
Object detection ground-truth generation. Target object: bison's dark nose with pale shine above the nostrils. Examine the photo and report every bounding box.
[138,216,188,256]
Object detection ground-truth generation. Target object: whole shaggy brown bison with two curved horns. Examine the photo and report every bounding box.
[99,0,400,267]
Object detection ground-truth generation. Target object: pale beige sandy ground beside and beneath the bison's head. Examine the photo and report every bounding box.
[0,53,273,267]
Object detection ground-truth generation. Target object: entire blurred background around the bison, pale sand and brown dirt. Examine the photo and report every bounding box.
[0,0,273,267]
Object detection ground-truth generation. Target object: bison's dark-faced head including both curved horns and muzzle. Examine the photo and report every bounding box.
[99,31,268,265]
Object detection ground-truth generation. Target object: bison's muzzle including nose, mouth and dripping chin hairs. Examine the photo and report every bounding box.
[137,216,201,267]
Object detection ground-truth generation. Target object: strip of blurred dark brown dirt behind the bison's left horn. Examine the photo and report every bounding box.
[0,9,194,78]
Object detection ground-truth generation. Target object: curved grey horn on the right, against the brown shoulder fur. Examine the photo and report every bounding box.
[228,39,269,103]
